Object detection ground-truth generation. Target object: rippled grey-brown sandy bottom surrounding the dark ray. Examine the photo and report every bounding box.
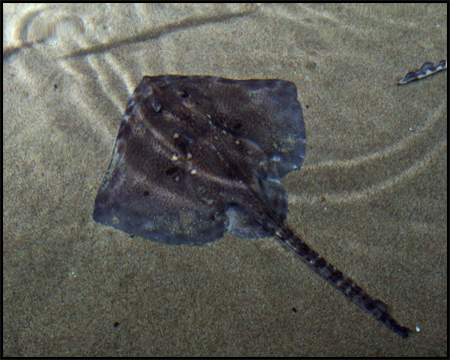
[3,4,448,356]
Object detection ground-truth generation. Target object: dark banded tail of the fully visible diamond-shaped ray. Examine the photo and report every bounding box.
[275,228,412,338]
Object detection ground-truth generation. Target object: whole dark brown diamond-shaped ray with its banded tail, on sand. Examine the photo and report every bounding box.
[93,75,411,338]
